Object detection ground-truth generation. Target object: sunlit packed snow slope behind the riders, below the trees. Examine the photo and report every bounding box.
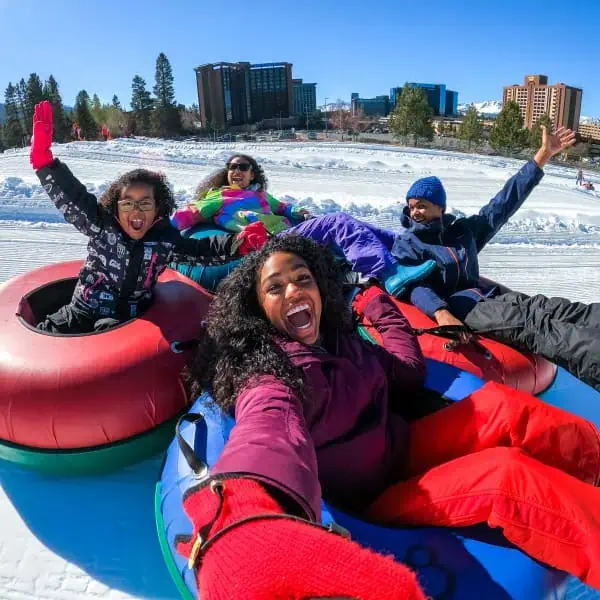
[0,138,600,302]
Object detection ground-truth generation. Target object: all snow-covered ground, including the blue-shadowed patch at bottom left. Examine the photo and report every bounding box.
[0,139,600,600]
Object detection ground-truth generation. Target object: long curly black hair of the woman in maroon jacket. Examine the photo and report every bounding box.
[188,234,352,412]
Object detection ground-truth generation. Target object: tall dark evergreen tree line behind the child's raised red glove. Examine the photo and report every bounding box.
[0,52,190,150]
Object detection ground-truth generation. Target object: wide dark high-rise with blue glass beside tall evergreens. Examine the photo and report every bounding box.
[194,62,294,127]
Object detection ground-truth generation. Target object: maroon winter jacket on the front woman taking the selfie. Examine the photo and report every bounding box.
[213,294,426,520]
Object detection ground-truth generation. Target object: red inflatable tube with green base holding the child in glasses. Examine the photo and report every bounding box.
[0,261,210,473]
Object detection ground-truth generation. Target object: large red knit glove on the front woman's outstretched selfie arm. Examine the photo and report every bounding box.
[177,478,425,600]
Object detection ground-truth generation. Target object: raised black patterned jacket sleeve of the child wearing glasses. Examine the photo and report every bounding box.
[36,159,103,236]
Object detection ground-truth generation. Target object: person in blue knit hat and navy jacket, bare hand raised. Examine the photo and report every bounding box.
[392,127,600,390]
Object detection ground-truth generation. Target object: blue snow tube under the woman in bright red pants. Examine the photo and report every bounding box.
[155,360,600,600]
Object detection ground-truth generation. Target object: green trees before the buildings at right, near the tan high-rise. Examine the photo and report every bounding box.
[389,84,552,153]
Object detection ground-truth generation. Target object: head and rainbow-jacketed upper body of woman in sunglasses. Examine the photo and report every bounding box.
[171,154,309,234]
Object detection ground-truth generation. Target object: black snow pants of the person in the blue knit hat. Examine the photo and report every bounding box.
[464,292,600,391]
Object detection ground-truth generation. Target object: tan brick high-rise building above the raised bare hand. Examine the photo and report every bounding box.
[502,75,583,131]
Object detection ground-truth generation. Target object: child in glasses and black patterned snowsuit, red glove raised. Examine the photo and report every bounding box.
[30,100,256,334]
